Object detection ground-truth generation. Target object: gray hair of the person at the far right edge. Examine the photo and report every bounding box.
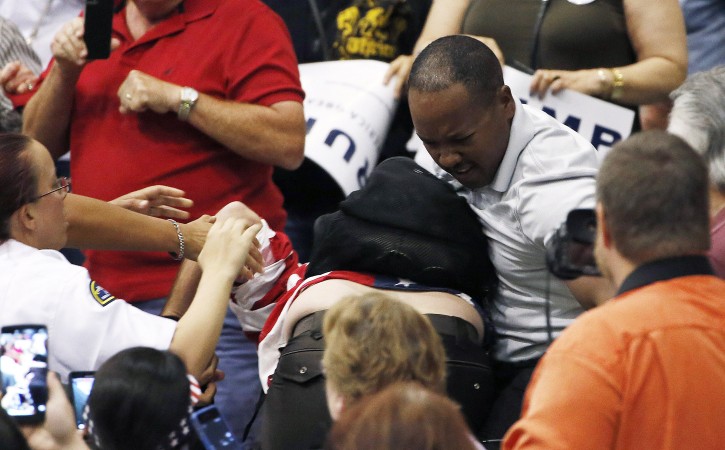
[668,65,725,193]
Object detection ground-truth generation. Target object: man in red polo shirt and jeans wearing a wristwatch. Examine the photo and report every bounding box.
[24,0,305,442]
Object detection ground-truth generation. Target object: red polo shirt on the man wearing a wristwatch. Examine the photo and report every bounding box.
[63,0,304,301]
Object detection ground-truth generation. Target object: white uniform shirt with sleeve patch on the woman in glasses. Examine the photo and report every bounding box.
[0,239,176,380]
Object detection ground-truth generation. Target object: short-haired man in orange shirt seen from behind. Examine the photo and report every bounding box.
[504,131,725,449]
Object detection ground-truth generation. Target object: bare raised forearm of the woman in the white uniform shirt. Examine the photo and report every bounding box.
[169,271,234,379]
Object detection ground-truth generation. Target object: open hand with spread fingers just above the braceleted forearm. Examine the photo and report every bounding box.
[109,185,194,219]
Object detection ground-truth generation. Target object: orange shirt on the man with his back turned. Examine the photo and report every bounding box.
[503,257,725,449]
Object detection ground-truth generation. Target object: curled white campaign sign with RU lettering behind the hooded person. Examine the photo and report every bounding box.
[300,60,397,196]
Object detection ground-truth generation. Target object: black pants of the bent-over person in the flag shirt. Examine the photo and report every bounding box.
[261,311,494,450]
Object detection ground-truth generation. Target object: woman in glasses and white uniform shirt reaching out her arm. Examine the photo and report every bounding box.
[0,134,259,382]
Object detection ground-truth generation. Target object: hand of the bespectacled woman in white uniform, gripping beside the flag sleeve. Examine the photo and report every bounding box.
[197,219,262,280]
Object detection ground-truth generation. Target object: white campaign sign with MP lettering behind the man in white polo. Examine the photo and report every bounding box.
[503,66,634,155]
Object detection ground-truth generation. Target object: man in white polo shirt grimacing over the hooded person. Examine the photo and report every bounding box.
[408,36,612,439]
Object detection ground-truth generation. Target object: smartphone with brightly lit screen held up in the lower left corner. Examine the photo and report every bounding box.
[0,325,48,423]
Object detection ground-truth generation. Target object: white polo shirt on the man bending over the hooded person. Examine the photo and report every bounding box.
[416,100,598,361]
